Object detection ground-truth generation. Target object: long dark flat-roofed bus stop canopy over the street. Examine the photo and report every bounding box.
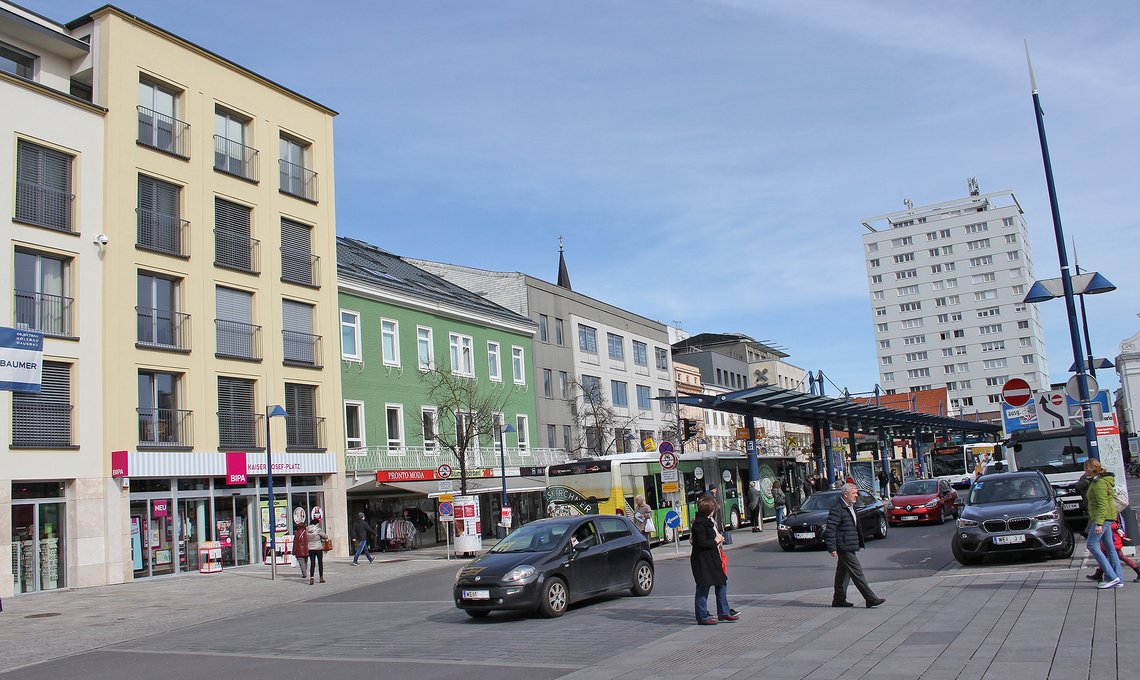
[658,384,1001,434]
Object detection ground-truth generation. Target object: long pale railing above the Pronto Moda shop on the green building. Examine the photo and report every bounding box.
[344,446,572,477]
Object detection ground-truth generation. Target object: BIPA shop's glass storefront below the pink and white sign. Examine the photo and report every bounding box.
[131,475,324,578]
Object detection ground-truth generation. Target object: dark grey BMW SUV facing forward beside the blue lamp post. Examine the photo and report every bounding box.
[950,470,1075,565]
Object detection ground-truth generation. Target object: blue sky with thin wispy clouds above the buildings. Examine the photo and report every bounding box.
[23,0,1140,391]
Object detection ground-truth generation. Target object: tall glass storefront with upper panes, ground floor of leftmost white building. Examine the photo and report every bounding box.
[11,481,67,593]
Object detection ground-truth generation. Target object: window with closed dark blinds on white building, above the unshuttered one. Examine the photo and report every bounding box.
[15,139,75,232]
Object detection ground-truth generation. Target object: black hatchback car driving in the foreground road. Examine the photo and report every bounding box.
[454,515,653,618]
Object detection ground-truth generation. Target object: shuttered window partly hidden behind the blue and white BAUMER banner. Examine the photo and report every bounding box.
[11,362,72,448]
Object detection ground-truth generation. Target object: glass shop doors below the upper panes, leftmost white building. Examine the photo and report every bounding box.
[11,501,66,592]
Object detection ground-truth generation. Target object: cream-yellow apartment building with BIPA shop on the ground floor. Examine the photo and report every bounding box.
[5,6,347,583]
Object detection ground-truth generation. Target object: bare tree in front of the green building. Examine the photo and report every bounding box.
[423,369,514,495]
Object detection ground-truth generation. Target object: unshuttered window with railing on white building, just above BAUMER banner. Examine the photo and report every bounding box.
[13,250,73,338]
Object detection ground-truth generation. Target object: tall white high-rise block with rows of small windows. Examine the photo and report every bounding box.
[863,185,1049,420]
